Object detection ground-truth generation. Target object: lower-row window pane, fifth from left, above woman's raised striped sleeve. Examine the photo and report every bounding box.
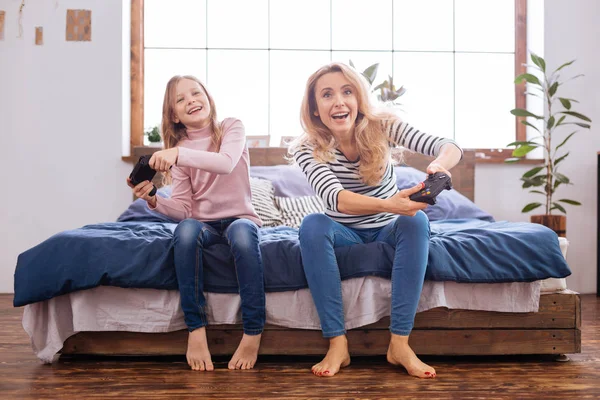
[394,53,454,138]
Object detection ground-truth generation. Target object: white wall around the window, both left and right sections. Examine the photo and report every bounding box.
[0,0,600,293]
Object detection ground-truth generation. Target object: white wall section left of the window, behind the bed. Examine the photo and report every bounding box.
[0,0,131,293]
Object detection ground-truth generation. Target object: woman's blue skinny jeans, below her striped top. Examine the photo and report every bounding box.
[300,211,430,338]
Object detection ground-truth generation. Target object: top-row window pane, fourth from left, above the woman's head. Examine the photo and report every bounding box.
[332,0,392,50]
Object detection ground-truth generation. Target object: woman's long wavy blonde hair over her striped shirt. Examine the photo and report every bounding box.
[290,63,397,185]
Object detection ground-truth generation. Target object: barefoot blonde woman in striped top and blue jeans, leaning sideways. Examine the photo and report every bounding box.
[290,63,462,378]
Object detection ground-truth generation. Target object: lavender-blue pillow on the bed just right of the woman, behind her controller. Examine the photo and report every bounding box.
[394,166,495,222]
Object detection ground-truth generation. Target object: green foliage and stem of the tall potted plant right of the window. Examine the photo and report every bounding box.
[506,53,592,215]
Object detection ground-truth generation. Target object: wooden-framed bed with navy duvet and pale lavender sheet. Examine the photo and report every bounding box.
[15,148,581,362]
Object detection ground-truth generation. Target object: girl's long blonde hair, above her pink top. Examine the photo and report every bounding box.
[161,75,223,151]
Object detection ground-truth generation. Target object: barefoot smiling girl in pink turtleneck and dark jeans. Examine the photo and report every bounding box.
[128,76,265,371]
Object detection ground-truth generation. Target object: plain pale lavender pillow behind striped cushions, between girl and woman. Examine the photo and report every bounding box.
[250,164,316,197]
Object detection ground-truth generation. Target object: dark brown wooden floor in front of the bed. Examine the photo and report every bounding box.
[0,295,600,399]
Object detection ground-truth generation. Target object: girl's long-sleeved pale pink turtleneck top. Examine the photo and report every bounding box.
[149,118,262,226]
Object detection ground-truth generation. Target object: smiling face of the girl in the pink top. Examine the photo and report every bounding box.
[173,78,211,129]
